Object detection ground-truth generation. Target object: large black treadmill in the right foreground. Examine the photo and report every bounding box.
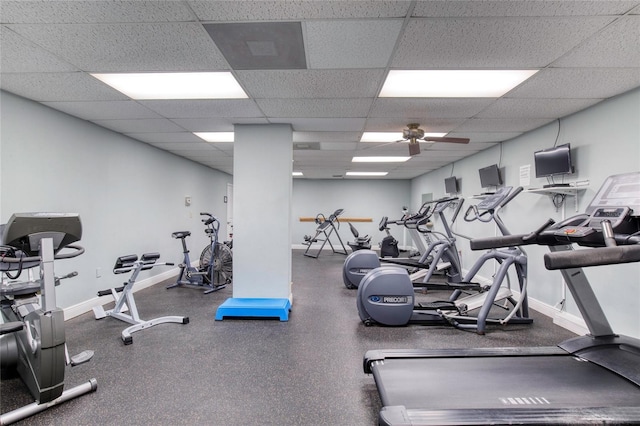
[364,172,640,425]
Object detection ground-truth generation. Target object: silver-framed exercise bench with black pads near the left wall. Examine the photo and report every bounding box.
[93,253,189,345]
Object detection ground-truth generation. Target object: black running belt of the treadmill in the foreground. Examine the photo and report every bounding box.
[371,356,640,410]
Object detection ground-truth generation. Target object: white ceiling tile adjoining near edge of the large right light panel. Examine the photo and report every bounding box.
[392,17,613,69]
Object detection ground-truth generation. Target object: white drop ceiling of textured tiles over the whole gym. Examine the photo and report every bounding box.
[0,0,640,179]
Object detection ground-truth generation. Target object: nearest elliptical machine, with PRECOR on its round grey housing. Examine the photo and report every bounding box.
[357,186,533,334]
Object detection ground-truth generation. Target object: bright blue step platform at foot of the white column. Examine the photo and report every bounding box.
[216,297,291,321]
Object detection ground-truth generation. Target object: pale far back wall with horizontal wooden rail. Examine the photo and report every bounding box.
[291,178,411,251]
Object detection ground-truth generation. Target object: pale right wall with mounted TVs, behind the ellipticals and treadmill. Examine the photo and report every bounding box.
[411,89,640,337]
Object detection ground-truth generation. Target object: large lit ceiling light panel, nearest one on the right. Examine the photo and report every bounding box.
[380,70,538,98]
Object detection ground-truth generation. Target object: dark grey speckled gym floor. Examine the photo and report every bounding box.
[0,250,574,426]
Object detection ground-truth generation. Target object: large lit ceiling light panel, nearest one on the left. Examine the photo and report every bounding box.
[91,71,248,100]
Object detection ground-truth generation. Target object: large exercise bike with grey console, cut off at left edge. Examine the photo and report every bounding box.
[0,213,98,425]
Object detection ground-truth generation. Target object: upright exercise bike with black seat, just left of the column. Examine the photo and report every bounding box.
[167,213,233,294]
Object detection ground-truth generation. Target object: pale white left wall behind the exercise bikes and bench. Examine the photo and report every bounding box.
[0,92,232,308]
